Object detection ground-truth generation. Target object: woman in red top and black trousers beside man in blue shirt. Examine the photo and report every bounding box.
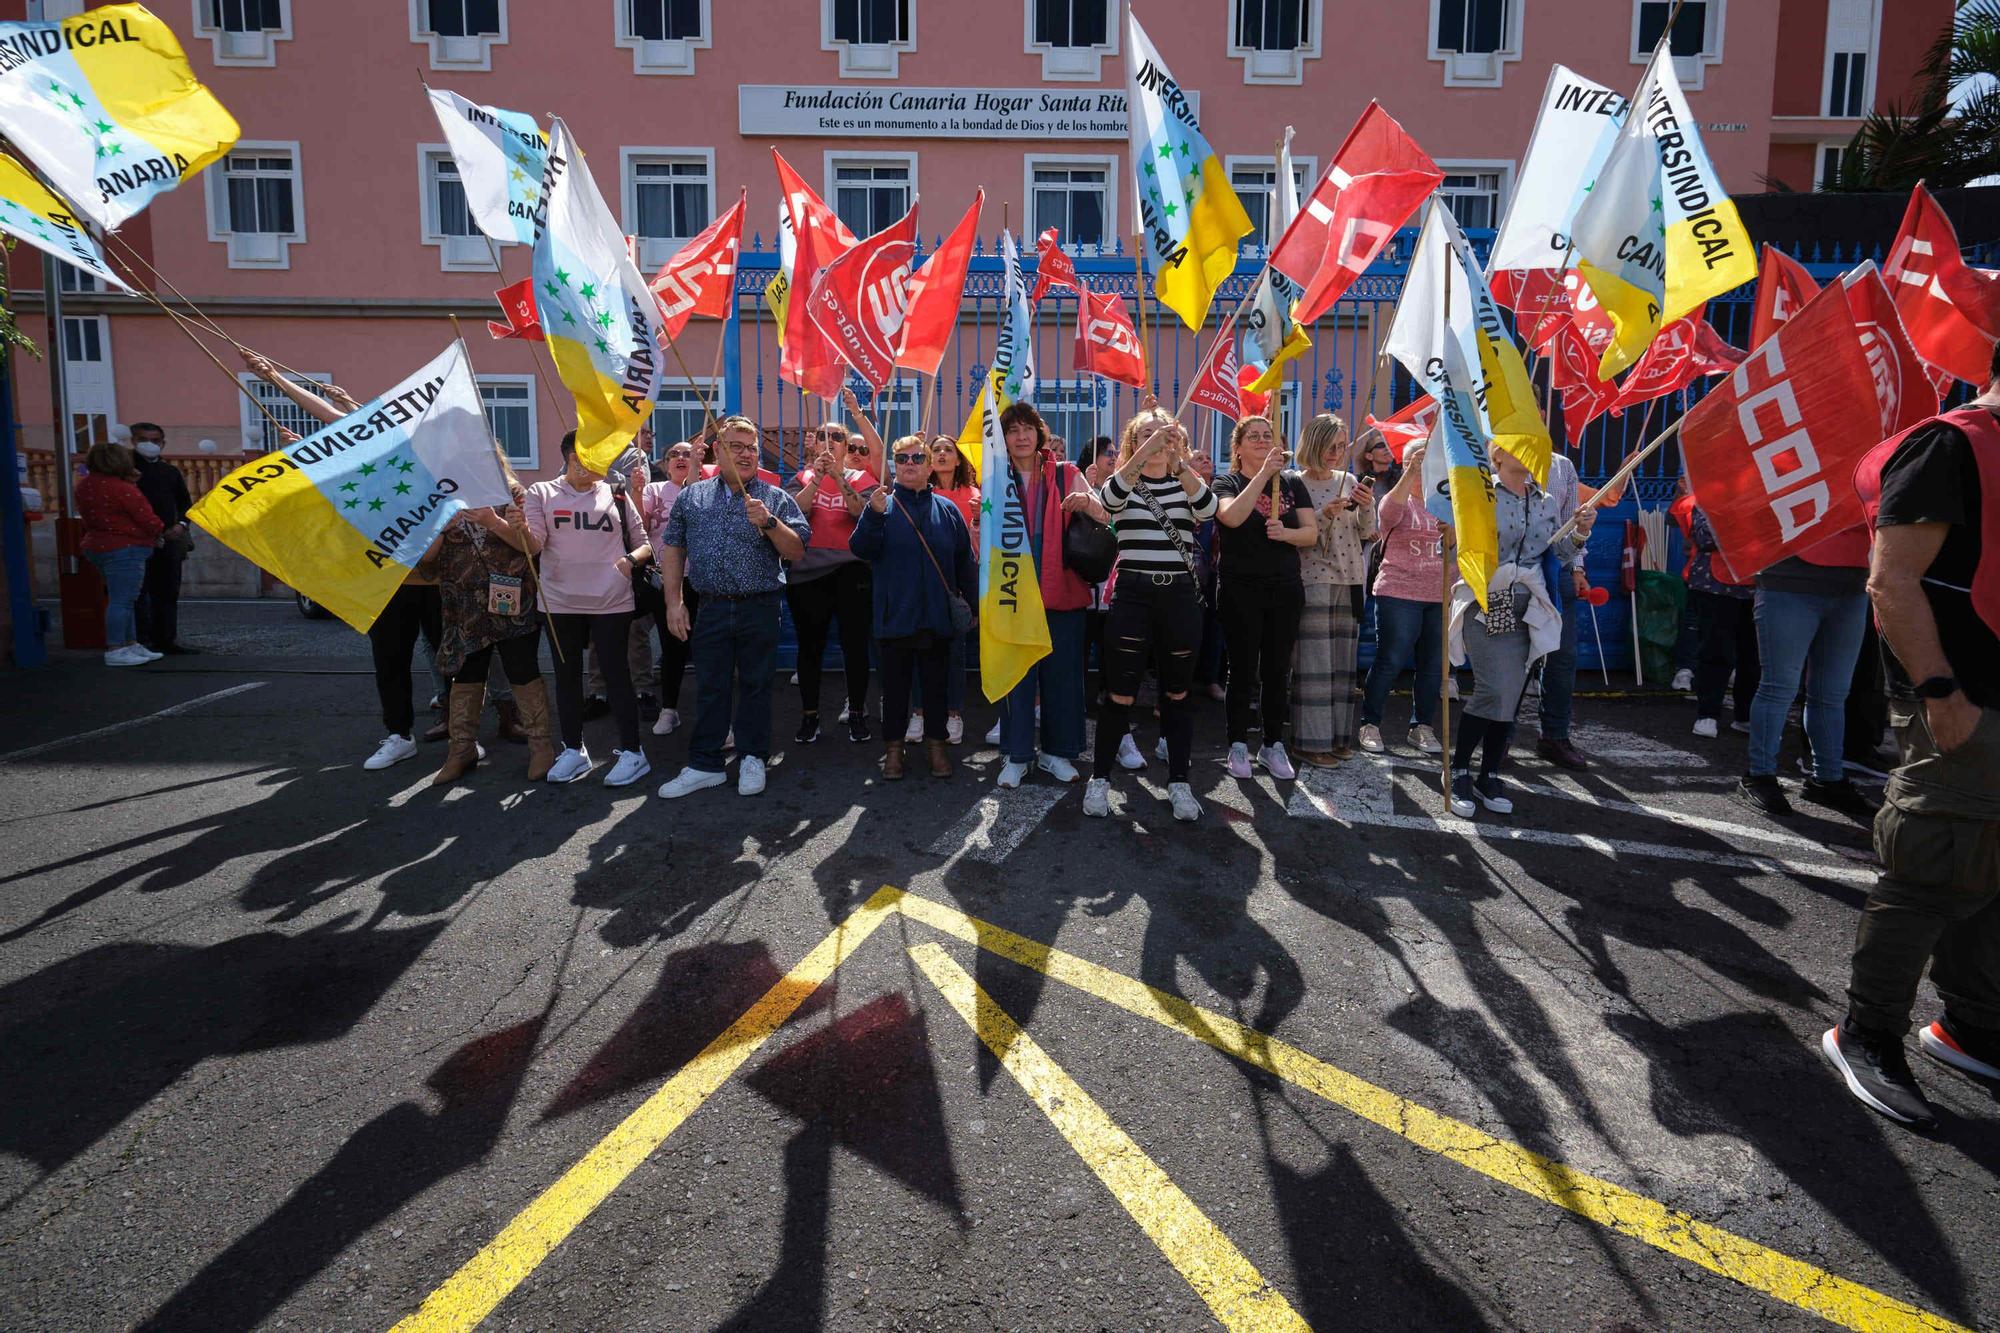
[784,390,882,745]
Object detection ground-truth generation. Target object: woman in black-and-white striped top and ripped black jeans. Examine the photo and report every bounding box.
[1084,408,1216,821]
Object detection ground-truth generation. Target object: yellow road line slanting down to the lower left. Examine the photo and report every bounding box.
[396,889,896,1333]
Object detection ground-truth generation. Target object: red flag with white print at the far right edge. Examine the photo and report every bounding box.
[1882,186,2000,384]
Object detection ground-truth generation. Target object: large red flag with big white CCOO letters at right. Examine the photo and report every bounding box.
[1680,286,1882,580]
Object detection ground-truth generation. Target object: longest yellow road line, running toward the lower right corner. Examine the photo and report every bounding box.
[896,891,1970,1333]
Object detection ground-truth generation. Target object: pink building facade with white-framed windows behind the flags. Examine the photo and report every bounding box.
[0,0,1950,490]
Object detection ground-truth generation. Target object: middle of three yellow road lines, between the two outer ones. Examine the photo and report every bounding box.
[910,932,1308,1333]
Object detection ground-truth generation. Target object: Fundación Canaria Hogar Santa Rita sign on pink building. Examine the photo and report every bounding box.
[736,84,1200,138]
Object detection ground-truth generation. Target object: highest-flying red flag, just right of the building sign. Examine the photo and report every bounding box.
[1270,102,1444,324]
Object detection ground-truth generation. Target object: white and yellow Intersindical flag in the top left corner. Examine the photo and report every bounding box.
[0,4,240,226]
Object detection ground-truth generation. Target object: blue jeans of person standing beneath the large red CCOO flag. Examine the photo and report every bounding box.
[1750,588,1868,783]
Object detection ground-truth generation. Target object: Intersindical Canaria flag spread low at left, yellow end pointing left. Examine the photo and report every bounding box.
[188,340,512,632]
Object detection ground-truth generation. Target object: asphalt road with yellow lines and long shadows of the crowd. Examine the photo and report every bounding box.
[0,604,2000,1333]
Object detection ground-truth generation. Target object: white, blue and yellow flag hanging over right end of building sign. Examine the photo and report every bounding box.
[1126,10,1252,328]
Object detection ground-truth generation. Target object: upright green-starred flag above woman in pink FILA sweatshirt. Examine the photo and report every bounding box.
[534,120,666,472]
